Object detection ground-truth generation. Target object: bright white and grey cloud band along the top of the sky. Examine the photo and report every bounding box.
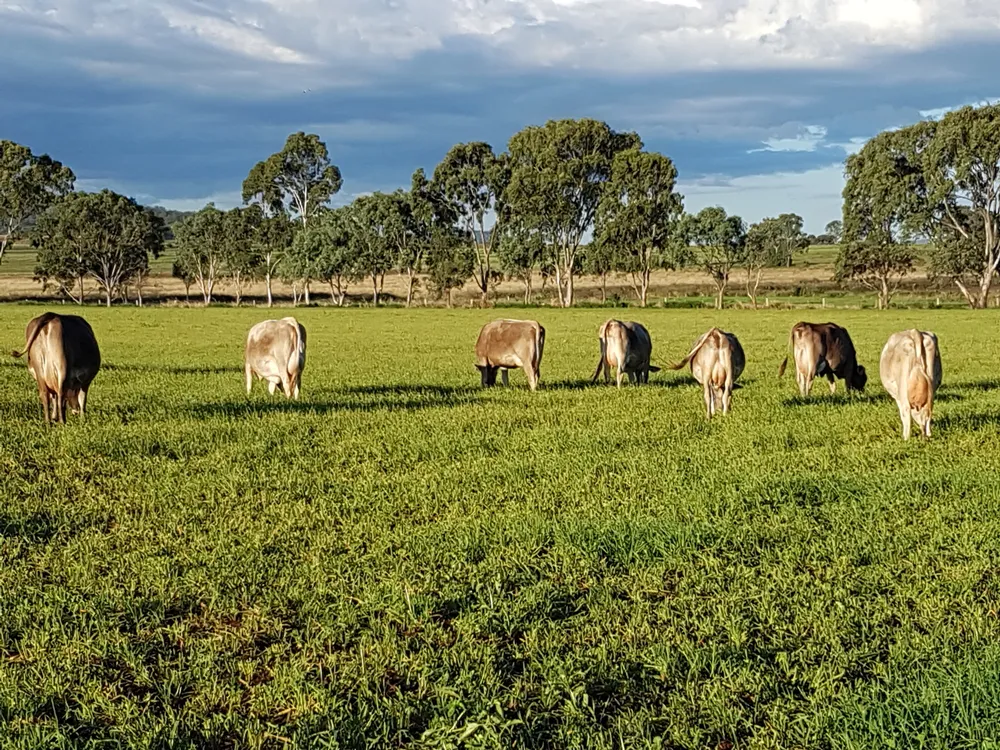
[0,0,1000,86]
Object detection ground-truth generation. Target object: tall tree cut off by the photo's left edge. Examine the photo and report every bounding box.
[0,141,76,262]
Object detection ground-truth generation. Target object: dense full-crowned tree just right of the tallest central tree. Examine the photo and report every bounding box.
[595,148,687,307]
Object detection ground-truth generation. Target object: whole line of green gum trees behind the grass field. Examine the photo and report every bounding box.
[0,106,1000,307]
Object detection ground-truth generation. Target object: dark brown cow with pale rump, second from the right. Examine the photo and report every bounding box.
[778,323,868,398]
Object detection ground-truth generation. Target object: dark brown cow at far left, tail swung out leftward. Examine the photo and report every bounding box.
[13,313,101,424]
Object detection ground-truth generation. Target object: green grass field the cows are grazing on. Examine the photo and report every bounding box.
[0,305,1000,750]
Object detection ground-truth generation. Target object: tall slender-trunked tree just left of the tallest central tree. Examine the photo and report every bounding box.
[433,142,510,305]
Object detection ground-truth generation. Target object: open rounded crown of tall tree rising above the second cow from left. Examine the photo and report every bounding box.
[243,131,344,225]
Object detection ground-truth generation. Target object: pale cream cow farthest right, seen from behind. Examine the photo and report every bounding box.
[879,328,941,440]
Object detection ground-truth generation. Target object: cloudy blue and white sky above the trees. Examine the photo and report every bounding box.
[0,0,1000,233]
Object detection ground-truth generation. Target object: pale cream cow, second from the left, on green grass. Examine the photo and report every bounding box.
[244,317,306,400]
